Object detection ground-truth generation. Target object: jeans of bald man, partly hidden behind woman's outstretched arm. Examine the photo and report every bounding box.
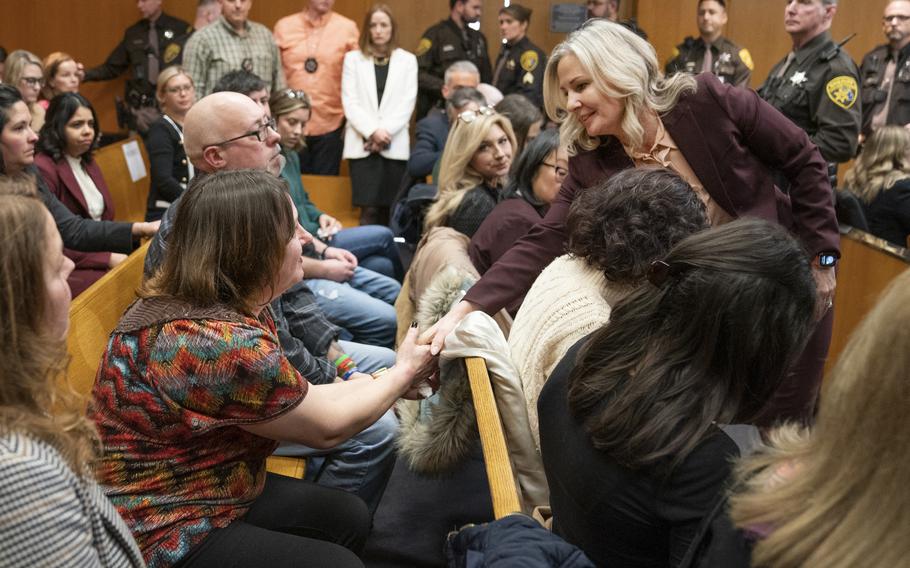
[275,341,398,513]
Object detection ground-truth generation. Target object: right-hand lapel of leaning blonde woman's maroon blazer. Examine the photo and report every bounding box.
[662,99,739,217]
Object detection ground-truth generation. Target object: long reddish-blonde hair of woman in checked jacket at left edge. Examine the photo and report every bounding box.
[0,189,99,474]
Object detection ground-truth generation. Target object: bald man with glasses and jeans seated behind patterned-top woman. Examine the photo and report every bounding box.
[145,92,398,510]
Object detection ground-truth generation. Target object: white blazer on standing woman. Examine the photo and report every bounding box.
[341,48,417,160]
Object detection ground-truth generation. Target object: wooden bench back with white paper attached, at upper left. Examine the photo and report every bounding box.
[95,136,151,223]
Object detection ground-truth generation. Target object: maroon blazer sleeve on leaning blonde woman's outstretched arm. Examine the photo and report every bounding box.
[464,178,580,315]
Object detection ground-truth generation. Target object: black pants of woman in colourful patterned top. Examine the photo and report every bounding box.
[176,473,370,568]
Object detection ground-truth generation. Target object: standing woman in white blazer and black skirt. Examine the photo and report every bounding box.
[341,4,417,225]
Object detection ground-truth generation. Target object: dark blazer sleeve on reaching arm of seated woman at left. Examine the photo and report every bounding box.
[38,177,133,254]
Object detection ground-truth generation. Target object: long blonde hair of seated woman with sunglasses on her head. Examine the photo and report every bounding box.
[424,113,517,231]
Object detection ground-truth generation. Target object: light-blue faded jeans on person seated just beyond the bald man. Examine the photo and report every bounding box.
[306,266,401,348]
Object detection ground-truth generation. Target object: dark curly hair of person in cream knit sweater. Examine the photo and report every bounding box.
[566,169,708,285]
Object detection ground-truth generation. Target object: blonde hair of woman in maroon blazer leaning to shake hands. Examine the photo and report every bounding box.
[543,18,696,154]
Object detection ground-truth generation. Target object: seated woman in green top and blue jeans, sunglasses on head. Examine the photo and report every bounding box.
[269,89,404,280]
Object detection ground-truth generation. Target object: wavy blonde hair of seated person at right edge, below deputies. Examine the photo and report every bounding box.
[844,125,910,203]
